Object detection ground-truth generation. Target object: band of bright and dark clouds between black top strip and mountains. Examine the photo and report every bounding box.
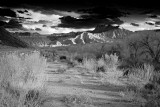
[0,6,160,34]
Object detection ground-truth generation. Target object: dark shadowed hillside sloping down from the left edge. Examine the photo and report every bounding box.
[0,27,30,48]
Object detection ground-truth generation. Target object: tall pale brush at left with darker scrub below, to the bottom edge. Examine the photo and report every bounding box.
[0,51,47,107]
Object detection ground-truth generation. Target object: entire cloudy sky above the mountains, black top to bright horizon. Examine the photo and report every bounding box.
[0,0,160,34]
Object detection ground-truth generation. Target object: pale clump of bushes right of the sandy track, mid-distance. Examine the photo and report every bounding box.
[82,54,123,85]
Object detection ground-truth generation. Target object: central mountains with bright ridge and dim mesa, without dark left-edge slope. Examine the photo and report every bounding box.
[9,25,134,47]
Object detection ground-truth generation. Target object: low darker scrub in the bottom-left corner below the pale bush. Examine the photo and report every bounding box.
[0,87,46,107]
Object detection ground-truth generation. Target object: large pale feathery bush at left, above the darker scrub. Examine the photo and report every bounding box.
[0,51,47,89]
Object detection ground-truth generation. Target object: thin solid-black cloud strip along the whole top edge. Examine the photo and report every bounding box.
[0,0,159,8]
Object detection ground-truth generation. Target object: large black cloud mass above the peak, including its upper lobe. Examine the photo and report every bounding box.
[55,6,126,28]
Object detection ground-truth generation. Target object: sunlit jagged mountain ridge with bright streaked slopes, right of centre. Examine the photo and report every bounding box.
[48,26,133,47]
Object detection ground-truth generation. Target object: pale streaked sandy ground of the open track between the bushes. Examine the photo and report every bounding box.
[44,63,140,107]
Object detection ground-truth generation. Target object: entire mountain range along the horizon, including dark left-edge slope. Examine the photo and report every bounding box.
[0,25,159,48]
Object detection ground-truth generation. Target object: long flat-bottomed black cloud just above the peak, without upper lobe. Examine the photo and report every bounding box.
[58,16,123,28]
